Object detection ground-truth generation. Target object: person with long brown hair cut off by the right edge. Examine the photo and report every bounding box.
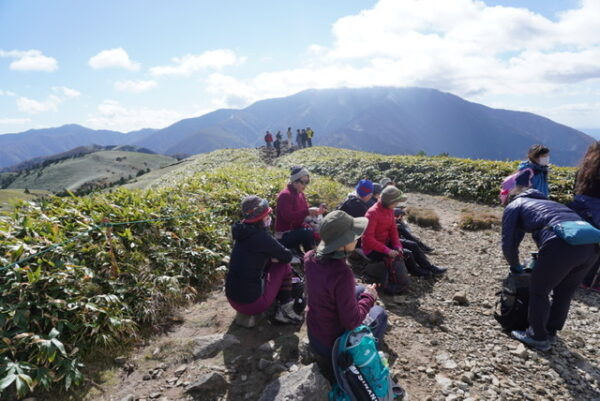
[568,141,600,292]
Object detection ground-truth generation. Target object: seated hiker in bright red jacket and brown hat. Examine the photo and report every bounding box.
[362,186,410,293]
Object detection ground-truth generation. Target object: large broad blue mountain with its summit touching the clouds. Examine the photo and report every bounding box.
[134,87,593,165]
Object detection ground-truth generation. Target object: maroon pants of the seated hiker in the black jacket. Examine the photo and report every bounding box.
[228,263,292,315]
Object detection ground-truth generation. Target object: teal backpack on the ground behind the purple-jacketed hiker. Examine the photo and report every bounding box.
[329,325,404,401]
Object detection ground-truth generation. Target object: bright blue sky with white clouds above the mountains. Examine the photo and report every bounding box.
[0,0,600,134]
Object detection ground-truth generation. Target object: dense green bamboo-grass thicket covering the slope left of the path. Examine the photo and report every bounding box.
[0,150,345,398]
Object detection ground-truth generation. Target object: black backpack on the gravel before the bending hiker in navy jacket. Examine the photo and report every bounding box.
[494,272,531,331]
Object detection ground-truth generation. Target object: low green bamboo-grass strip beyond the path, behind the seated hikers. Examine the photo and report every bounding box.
[277,146,575,205]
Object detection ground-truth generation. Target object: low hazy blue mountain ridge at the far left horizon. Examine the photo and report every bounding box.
[0,124,156,168]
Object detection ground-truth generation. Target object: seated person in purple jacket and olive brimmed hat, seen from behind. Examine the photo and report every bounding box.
[304,210,387,360]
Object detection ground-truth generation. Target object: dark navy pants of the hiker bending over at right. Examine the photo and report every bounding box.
[529,237,599,340]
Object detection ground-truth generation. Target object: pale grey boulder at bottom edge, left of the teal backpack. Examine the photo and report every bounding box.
[259,363,330,401]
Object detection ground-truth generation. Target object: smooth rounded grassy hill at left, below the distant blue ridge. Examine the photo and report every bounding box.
[7,151,176,192]
